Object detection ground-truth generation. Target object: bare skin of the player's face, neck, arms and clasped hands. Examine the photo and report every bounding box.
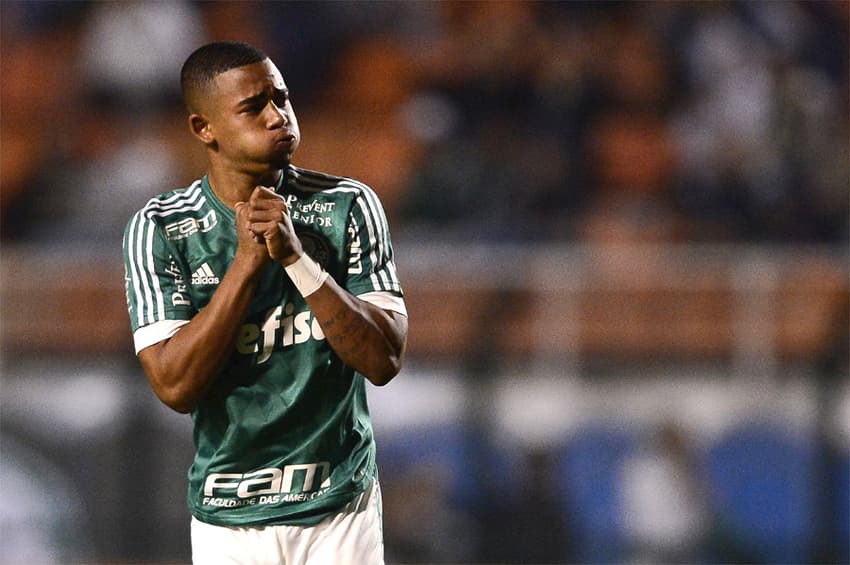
[139,59,407,413]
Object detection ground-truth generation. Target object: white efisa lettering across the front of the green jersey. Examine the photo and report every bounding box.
[236,302,325,365]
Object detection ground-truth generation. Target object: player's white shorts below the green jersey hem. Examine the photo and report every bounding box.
[192,482,384,565]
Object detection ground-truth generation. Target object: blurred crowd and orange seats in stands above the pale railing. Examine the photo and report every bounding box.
[0,1,850,246]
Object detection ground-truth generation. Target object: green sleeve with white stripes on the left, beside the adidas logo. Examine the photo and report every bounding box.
[123,210,196,334]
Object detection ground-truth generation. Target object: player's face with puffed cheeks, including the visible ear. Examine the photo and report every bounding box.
[199,59,301,174]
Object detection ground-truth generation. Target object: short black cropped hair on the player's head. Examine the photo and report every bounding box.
[180,41,268,112]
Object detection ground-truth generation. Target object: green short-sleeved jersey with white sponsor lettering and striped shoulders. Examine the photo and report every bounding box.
[124,166,402,526]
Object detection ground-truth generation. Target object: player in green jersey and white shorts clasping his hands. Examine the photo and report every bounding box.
[124,42,407,564]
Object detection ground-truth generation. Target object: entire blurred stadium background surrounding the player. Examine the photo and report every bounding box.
[0,1,850,564]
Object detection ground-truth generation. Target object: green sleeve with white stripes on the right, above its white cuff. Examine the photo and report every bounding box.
[346,186,403,296]
